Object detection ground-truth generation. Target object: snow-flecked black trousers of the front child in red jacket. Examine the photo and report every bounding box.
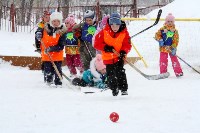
[106,62,128,91]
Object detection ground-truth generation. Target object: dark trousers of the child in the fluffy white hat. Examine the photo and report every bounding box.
[43,61,62,85]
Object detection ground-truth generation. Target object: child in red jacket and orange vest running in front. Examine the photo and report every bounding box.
[94,13,131,96]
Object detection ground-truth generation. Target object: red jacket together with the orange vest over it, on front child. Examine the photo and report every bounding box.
[94,21,132,64]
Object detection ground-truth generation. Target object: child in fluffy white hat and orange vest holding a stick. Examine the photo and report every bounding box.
[36,12,66,86]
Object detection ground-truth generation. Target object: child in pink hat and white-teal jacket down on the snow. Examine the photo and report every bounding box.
[72,54,107,89]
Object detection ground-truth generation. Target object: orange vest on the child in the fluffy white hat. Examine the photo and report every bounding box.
[41,30,64,61]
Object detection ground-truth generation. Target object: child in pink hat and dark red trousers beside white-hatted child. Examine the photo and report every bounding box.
[65,15,84,77]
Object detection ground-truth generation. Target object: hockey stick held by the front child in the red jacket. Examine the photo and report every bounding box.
[113,49,170,80]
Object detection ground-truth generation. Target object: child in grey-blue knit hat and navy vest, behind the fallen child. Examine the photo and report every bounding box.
[73,10,96,70]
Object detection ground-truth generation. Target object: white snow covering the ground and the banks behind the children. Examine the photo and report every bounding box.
[0,0,200,133]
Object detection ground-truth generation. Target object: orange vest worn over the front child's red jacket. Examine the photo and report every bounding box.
[102,30,125,60]
